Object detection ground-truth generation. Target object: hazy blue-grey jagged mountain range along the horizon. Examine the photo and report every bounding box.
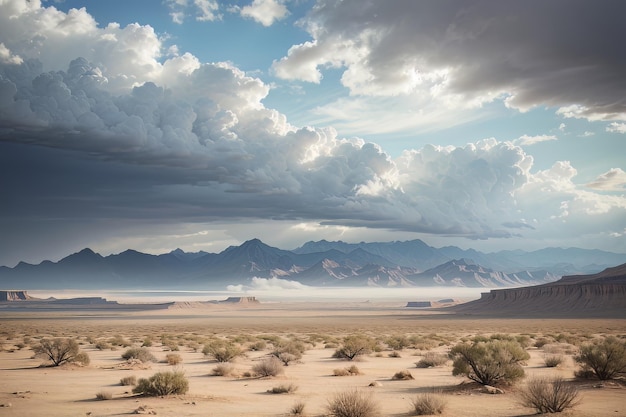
[0,239,626,290]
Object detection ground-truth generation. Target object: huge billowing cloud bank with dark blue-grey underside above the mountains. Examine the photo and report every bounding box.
[0,1,626,264]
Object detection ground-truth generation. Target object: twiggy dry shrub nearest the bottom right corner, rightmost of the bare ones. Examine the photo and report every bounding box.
[519,378,578,414]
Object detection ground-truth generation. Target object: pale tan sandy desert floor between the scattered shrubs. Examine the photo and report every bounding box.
[0,302,626,417]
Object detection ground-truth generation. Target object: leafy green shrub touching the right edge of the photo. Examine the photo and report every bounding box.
[574,336,626,380]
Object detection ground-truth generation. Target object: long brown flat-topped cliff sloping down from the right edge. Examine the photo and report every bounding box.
[452,264,626,317]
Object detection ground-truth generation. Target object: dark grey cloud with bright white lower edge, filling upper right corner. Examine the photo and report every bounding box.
[274,0,626,120]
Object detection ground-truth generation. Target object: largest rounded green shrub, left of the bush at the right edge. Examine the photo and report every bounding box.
[450,340,530,385]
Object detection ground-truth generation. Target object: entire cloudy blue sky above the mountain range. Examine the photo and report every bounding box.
[0,0,626,266]
